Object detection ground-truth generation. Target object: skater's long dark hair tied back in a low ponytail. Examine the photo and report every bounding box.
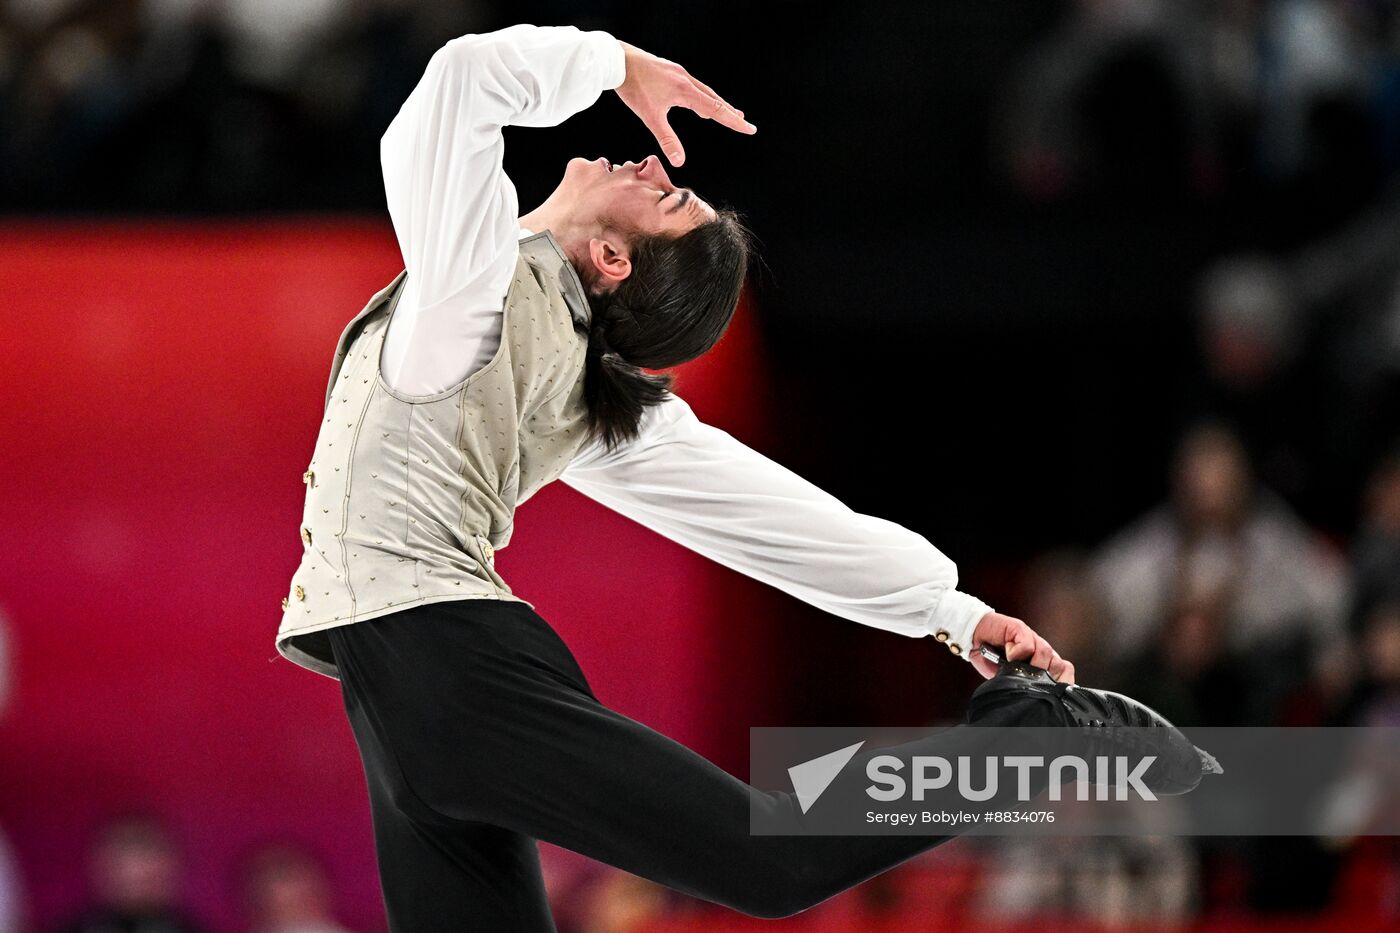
[584,210,752,450]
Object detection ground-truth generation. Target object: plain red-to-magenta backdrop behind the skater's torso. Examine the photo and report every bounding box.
[0,221,802,929]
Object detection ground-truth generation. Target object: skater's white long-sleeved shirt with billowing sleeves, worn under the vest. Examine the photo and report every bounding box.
[369,25,991,657]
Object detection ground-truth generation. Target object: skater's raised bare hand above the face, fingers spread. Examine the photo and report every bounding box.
[616,42,759,165]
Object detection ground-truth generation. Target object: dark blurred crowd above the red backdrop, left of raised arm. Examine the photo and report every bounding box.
[0,0,498,212]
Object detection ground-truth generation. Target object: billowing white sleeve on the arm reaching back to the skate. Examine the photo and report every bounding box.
[560,395,991,657]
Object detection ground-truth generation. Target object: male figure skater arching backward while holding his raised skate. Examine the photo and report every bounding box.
[276,25,1204,933]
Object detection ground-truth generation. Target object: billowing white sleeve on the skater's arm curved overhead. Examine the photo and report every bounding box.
[379,25,626,395]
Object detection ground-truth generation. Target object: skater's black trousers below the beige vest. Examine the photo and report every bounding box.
[329,600,1049,933]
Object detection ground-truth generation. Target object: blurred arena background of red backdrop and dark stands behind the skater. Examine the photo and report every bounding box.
[0,0,1400,933]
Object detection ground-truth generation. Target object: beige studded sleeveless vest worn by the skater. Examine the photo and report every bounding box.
[276,231,589,679]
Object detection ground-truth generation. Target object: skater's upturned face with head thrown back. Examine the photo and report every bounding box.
[556,156,715,237]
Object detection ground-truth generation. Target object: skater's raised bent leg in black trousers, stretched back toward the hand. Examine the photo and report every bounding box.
[322,604,1039,916]
